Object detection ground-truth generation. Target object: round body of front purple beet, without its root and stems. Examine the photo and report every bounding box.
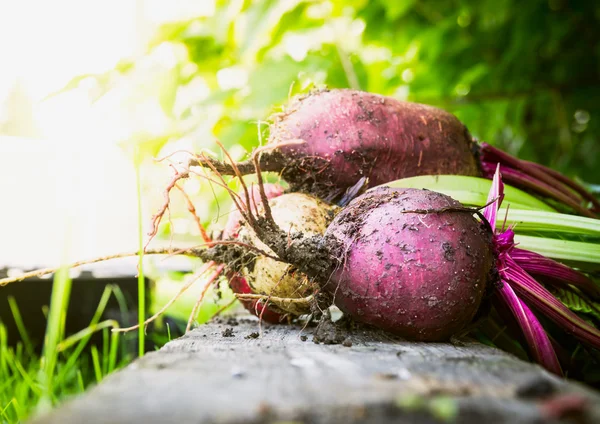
[325,187,494,341]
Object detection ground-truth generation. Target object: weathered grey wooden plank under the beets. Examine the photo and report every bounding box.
[33,320,600,424]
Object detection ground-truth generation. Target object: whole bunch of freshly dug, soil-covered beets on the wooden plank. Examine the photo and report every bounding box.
[165,90,600,374]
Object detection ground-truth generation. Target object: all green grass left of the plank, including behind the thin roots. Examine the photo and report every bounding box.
[0,268,239,424]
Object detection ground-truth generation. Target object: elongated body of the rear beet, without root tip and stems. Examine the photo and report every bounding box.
[269,90,479,197]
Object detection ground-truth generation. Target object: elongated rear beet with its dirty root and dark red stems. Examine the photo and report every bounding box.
[192,90,600,217]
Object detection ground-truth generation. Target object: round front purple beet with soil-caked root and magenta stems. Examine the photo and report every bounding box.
[198,171,600,375]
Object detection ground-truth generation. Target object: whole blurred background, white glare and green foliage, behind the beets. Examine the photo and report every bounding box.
[0,0,600,420]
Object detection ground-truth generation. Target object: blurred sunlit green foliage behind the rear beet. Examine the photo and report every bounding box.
[71,0,600,183]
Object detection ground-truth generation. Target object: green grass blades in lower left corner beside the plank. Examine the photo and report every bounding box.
[0,284,126,423]
